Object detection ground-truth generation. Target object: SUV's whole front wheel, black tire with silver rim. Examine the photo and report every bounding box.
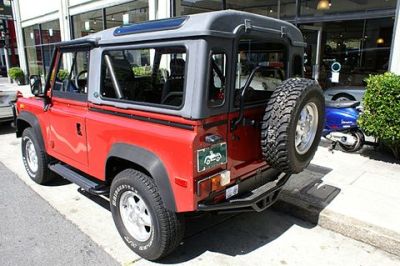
[21,127,54,185]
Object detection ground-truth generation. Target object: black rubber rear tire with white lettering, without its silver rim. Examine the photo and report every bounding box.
[110,169,185,261]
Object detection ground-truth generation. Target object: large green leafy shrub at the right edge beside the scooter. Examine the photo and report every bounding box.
[358,73,400,158]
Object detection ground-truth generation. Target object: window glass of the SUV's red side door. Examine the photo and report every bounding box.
[53,51,89,94]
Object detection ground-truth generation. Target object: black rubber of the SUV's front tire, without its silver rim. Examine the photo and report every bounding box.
[21,127,55,185]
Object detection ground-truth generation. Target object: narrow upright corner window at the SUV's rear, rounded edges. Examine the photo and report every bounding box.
[208,53,226,107]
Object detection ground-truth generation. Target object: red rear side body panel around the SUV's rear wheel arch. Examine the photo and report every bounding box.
[86,105,196,212]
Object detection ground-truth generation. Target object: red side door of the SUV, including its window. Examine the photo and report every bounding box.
[47,48,89,168]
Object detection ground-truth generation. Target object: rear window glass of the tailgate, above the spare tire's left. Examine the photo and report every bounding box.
[235,36,287,105]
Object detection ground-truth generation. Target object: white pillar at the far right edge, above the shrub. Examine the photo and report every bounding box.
[389,0,400,75]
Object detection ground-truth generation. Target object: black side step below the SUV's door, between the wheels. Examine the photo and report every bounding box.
[49,163,110,195]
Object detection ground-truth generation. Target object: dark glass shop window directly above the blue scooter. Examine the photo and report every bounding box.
[300,18,393,88]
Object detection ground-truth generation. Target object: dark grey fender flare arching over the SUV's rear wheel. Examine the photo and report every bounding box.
[104,143,176,212]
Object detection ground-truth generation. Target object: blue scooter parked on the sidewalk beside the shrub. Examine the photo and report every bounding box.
[322,101,365,152]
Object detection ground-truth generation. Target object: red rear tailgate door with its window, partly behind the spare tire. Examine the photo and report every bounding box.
[227,34,287,178]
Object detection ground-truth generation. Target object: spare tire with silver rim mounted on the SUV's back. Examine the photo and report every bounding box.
[261,78,325,173]
